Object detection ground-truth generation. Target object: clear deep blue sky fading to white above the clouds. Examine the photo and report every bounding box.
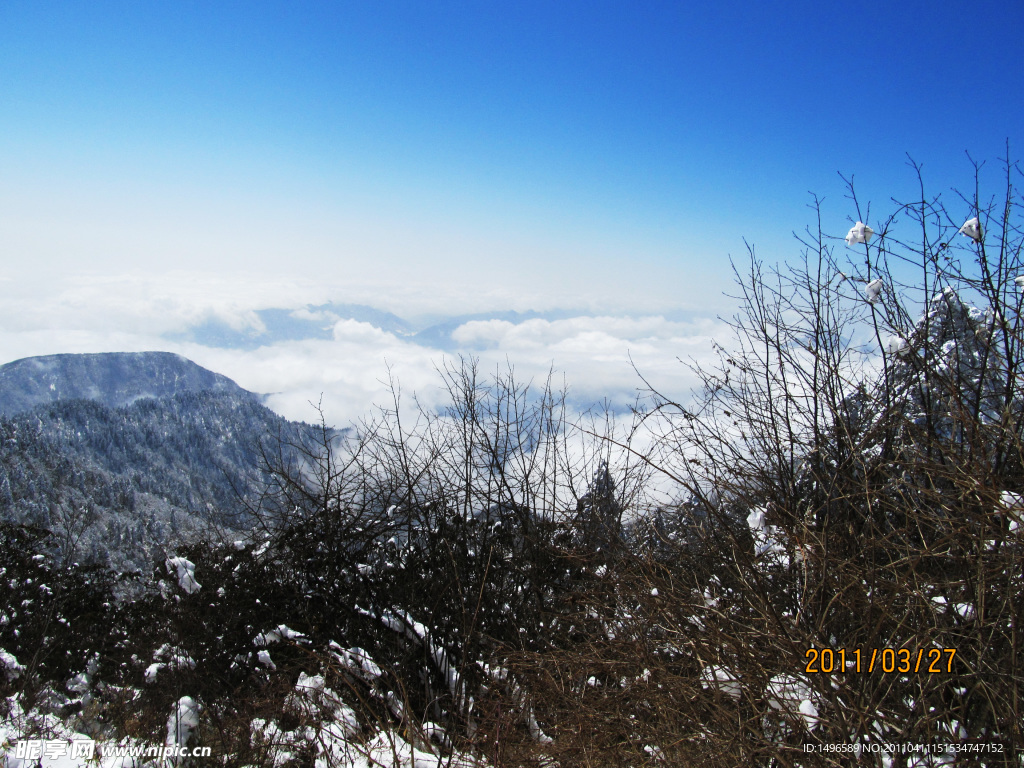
[0,0,1024,421]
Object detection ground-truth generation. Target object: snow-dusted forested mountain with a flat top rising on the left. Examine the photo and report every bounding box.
[0,352,327,570]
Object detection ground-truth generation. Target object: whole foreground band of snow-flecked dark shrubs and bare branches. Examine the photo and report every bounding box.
[0,160,1024,768]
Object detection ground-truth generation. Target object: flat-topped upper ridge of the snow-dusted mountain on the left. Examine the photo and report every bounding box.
[0,352,259,416]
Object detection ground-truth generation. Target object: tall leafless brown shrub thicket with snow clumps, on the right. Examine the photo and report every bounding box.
[491,153,1024,766]
